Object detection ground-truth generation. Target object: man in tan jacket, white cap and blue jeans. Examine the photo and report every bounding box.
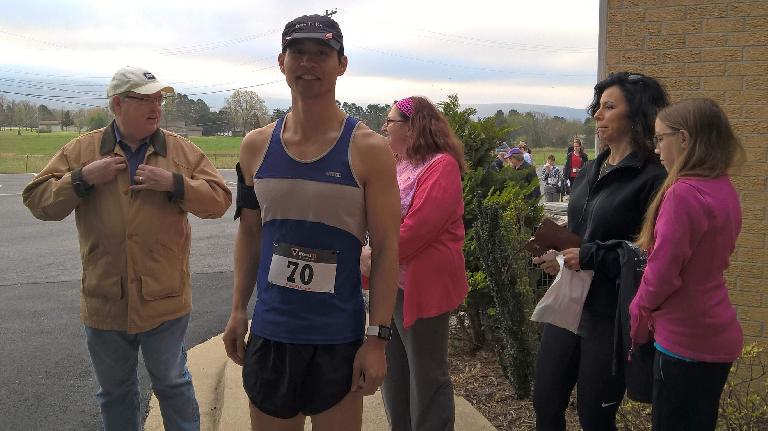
[23,67,232,431]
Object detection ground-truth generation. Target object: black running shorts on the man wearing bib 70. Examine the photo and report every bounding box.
[243,335,363,419]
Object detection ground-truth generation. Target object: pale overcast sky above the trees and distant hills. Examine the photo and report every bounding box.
[0,0,598,108]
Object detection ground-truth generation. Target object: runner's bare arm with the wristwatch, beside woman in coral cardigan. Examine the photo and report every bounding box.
[352,125,400,395]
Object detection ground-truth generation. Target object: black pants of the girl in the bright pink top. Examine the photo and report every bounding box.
[653,351,731,431]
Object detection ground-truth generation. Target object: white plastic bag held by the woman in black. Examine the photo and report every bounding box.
[531,254,593,334]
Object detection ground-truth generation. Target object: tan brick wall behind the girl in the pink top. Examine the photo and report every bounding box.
[601,0,768,344]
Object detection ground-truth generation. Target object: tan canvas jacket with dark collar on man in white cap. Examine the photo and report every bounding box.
[22,125,232,333]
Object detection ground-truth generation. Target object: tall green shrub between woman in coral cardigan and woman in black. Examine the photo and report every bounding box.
[439,95,542,398]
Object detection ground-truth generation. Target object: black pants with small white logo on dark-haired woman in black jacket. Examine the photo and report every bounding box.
[533,319,624,431]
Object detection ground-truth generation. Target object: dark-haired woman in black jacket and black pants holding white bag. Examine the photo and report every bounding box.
[533,72,668,431]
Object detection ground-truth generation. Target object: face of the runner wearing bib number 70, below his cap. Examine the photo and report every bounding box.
[278,39,347,97]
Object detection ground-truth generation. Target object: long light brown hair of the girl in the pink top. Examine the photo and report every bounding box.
[637,99,745,250]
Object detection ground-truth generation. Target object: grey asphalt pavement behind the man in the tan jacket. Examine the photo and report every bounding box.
[0,170,255,431]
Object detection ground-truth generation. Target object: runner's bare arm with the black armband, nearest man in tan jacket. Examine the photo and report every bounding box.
[223,126,271,365]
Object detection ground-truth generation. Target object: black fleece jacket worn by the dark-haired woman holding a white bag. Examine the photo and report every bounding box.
[568,149,667,328]
